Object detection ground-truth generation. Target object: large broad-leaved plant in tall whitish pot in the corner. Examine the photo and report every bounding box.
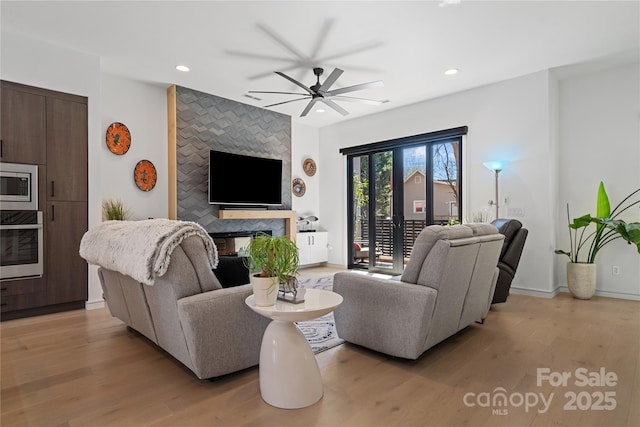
[555,182,640,299]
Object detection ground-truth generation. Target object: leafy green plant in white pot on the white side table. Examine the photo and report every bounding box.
[244,233,299,306]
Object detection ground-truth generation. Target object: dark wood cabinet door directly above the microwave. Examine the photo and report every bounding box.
[0,81,46,164]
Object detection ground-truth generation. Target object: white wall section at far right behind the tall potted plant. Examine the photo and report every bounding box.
[555,64,640,299]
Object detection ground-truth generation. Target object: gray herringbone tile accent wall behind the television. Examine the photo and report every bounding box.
[176,86,291,235]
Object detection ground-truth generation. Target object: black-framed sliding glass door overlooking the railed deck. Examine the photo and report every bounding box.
[347,130,461,274]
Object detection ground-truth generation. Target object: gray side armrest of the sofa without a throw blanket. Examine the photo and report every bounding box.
[333,272,437,359]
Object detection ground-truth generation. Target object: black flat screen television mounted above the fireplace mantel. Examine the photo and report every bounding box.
[209,150,282,206]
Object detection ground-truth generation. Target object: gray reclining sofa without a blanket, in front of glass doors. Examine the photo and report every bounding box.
[333,224,504,359]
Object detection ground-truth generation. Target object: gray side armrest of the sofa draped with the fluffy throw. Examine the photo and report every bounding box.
[178,285,270,378]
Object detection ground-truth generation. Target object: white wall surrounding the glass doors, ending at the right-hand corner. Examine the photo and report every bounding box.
[320,72,555,295]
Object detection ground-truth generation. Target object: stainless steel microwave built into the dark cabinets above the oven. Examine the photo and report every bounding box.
[0,163,38,211]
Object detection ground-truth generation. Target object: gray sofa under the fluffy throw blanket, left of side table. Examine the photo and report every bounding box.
[81,222,269,379]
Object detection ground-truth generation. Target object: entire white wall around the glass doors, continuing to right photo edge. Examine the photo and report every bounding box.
[320,64,640,299]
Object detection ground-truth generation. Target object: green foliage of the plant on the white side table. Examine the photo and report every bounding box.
[244,233,299,283]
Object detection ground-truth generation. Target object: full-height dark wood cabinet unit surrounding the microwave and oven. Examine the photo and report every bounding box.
[0,81,88,320]
